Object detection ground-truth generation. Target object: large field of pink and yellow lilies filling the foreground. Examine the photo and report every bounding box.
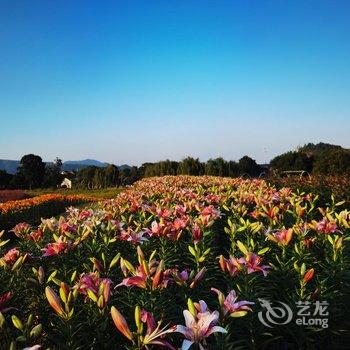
[0,176,350,350]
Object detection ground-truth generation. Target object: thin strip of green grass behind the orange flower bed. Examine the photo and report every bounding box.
[25,187,123,199]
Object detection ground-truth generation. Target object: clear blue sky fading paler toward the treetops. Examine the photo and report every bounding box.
[0,0,350,165]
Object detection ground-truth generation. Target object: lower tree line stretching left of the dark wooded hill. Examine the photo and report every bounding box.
[0,154,263,189]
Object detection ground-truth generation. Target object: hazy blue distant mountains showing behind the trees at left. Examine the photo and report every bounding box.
[0,159,131,174]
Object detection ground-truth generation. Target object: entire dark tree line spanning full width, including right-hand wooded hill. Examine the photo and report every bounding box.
[0,143,350,189]
